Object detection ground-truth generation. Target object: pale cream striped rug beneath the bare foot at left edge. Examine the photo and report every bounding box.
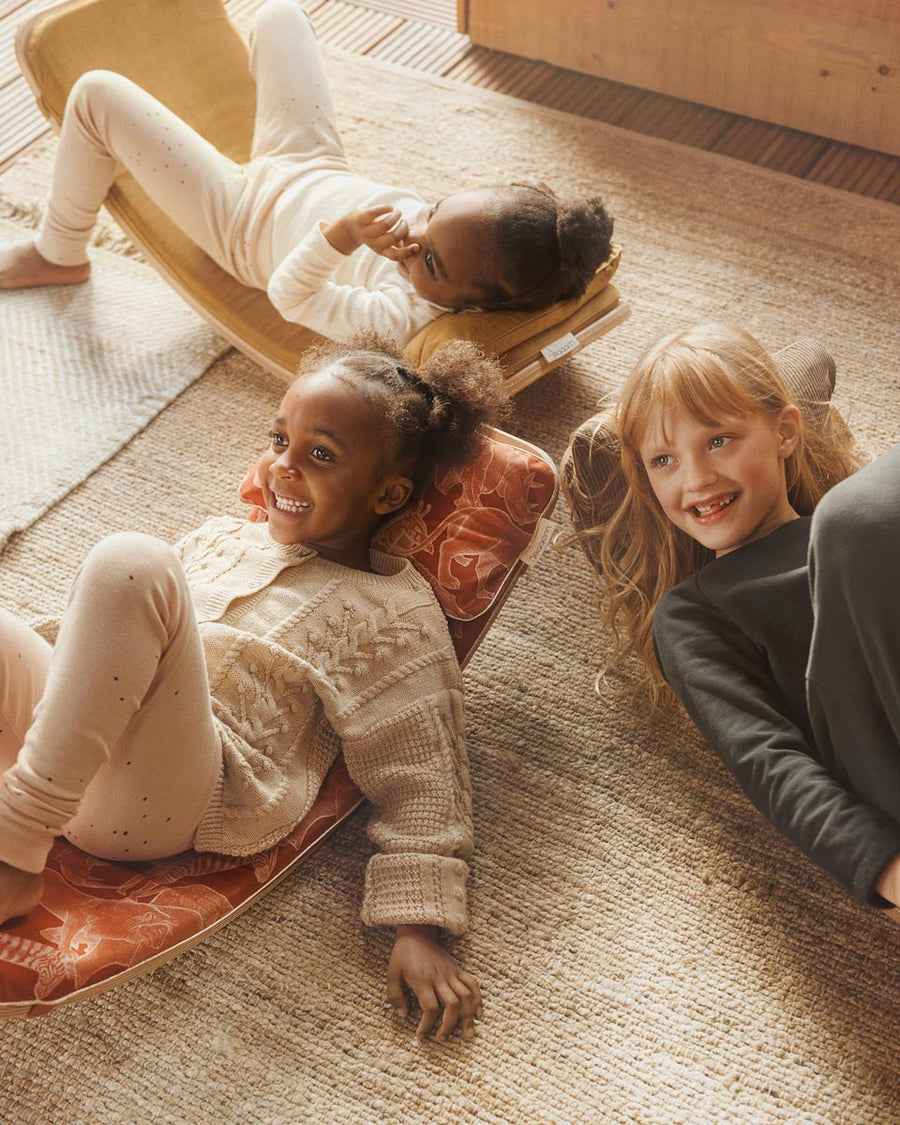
[0,210,227,547]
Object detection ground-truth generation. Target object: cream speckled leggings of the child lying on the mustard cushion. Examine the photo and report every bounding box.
[36,0,348,288]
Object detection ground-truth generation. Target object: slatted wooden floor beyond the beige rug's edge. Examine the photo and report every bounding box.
[0,0,900,204]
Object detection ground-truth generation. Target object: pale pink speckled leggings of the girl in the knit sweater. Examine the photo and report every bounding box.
[0,533,222,871]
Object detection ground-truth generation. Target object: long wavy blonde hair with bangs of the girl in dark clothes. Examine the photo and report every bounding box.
[586,324,866,704]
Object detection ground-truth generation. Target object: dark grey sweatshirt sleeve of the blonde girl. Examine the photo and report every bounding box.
[654,582,900,907]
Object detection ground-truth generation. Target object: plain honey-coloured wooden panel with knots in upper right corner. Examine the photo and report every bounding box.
[459,0,900,155]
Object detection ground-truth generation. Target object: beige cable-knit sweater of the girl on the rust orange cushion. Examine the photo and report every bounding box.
[179,518,471,933]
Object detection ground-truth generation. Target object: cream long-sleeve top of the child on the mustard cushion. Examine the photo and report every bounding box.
[266,169,448,344]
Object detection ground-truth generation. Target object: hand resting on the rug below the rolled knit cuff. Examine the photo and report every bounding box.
[387,926,482,1043]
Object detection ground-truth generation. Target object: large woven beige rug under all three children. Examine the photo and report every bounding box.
[0,46,900,1125]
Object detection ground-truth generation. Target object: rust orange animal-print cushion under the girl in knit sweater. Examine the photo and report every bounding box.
[0,432,557,1018]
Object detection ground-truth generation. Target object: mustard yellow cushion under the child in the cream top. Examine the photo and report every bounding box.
[16,0,620,379]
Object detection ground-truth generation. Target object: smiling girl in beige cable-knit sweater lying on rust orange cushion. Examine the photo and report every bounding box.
[0,342,503,1040]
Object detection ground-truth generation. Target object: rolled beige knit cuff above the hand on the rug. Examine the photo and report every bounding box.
[361,853,469,934]
